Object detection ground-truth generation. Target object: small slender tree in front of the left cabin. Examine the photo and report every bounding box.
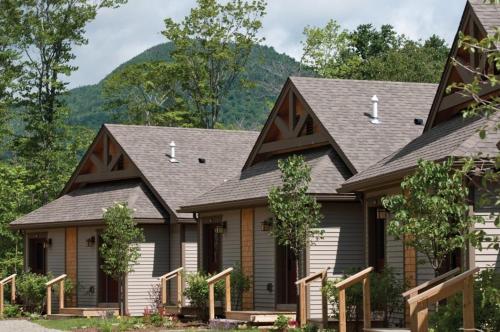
[99,203,144,315]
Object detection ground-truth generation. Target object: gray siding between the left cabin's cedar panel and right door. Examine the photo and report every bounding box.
[77,227,99,307]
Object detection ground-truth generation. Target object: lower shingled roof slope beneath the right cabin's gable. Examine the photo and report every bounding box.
[341,116,500,192]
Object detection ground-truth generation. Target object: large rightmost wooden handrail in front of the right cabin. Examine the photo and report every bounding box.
[407,267,479,332]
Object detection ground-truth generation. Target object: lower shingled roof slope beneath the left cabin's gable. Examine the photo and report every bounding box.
[11,180,168,227]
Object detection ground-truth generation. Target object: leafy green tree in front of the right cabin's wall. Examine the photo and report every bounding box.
[382,158,484,276]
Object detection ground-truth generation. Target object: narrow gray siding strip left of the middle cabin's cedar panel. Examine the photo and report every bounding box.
[222,210,241,268]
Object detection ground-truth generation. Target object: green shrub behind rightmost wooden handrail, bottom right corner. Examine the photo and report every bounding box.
[430,270,500,332]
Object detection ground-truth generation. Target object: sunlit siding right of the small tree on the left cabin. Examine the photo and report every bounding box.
[127,225,169,316]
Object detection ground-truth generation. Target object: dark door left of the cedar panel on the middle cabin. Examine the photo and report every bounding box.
[203,224,222,273]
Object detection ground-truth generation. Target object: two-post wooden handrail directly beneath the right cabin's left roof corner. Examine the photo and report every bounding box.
[335,266,373,332]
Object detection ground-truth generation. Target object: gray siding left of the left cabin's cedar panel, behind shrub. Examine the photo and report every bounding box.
[47,228,66,313]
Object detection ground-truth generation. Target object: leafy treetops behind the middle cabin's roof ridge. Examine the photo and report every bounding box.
[301,20,448,82]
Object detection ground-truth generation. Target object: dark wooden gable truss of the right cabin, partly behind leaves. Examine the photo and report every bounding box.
[426,4,499,129]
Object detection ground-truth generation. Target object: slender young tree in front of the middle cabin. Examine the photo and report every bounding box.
[268,155,323,322]
